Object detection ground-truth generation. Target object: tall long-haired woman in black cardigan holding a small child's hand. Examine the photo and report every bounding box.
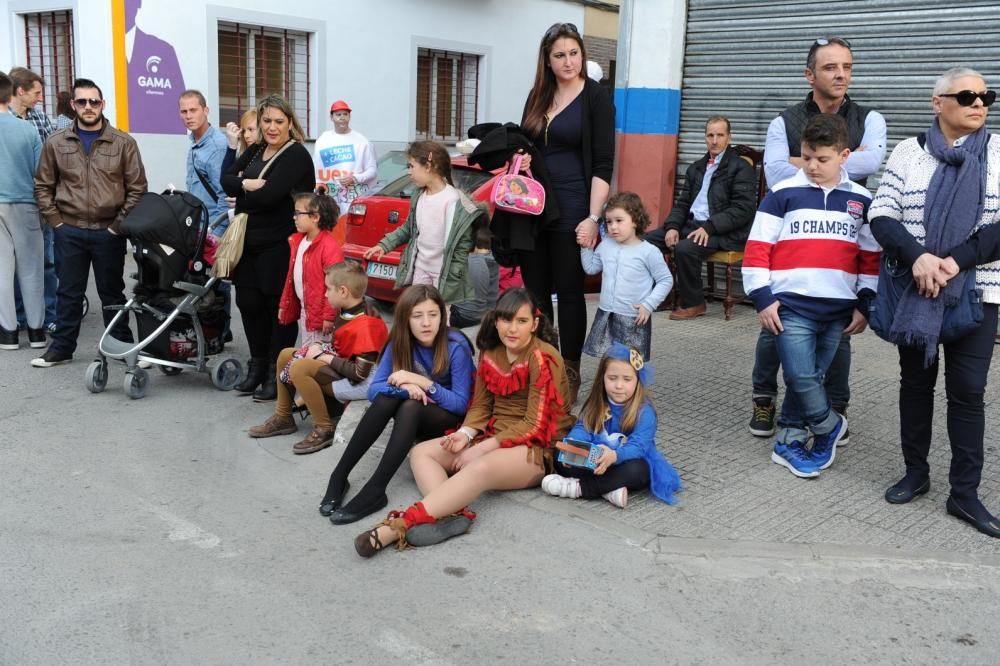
[520,23,615,403]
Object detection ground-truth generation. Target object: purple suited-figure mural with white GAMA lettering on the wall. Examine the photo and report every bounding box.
[125,0,187,134]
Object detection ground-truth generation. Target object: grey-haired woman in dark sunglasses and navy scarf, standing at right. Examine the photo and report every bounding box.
[869,68,1000,537]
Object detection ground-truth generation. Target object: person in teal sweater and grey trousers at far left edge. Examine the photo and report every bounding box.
[0,73,45,349]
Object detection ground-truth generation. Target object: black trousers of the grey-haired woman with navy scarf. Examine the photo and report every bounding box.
[899,304,997,500]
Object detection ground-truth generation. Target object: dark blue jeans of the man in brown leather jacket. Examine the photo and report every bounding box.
[49,224,132,355]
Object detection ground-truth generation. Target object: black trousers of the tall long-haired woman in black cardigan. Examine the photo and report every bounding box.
[520,231,587,362]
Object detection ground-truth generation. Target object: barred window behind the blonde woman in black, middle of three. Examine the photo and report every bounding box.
[219,21,312,136]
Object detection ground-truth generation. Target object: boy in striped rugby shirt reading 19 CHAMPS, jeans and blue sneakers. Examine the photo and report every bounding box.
[743,114,880,478]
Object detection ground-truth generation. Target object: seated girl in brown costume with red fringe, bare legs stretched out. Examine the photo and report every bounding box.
[354,289,574,557]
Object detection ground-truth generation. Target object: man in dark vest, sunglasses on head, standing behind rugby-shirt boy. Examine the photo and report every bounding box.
[749,37,886,438]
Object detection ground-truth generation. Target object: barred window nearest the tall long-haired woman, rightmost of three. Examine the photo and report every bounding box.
[416,48,479,141]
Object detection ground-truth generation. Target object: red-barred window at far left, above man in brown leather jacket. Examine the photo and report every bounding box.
[22,10,74,117]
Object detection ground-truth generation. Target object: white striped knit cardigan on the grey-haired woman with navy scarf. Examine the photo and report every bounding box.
[868,135,1000,303]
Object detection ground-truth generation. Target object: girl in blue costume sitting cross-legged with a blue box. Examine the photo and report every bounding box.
[542,343,681,509]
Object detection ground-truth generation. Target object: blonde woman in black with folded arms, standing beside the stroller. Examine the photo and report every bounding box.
[222,95,316,401]
